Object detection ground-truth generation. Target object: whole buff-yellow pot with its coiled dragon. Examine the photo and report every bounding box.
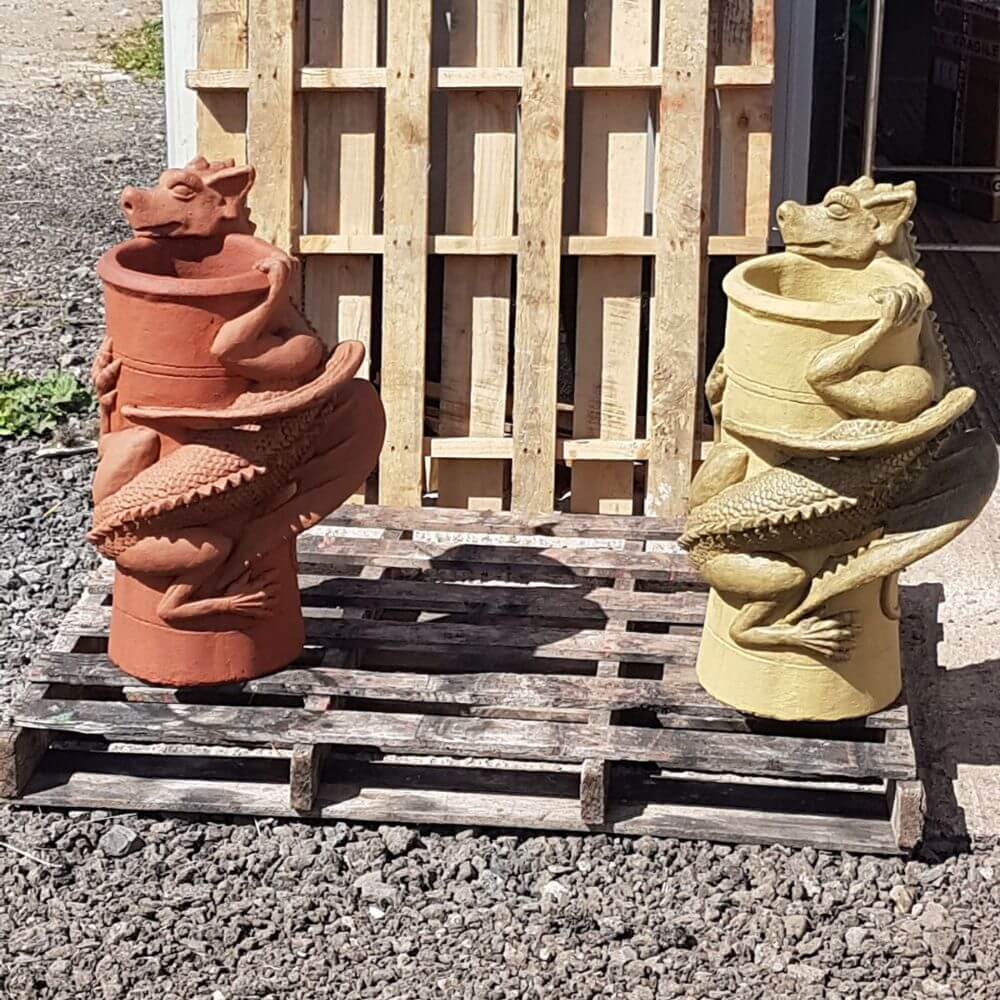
[681,178,997,720]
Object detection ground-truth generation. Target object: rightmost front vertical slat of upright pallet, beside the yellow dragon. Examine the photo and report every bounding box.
[646,0,712,515]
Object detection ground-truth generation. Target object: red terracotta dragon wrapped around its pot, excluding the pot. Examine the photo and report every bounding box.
[88,157,385,627]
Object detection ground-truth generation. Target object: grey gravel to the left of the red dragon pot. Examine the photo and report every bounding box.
[0,82,166,718]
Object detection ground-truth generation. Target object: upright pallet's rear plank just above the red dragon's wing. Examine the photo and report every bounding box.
[305,0,384,376]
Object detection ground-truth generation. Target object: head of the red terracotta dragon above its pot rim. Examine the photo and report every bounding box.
[119,156,255,238]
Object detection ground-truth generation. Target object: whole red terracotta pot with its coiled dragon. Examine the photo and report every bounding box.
[88,158,385,686]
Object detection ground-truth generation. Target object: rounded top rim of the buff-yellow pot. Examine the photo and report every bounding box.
[722,252,931,326]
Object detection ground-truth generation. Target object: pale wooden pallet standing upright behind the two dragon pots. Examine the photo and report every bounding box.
[188,0,773,516]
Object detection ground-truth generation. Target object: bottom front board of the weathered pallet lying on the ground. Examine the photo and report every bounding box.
[7,752,898,854]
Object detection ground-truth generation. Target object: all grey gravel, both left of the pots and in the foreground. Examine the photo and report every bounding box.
[0,74,1000,1000]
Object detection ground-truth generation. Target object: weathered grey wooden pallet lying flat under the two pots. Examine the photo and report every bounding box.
[0,507,922,853]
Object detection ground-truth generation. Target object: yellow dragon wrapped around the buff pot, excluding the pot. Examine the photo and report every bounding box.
[680,178,997,661]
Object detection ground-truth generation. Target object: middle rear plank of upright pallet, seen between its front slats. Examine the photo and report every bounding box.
[437,0,518,510]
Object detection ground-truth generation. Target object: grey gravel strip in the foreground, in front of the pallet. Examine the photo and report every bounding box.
[0,813,1000,1000]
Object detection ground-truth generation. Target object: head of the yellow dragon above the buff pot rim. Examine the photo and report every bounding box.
[777,177,917,262]
